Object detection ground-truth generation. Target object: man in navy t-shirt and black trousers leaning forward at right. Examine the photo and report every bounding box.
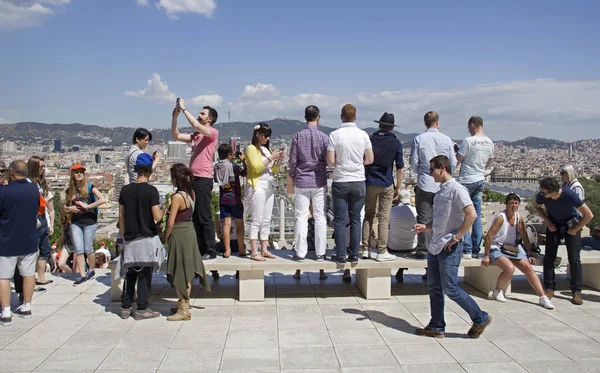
[535,177,594,305]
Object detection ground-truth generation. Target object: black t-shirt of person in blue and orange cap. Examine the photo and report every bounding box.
[119,183,159,241]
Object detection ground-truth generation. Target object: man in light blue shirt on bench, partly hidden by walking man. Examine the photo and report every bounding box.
[410,111,456,259]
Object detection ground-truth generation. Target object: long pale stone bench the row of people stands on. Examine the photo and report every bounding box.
[109,250,510,302]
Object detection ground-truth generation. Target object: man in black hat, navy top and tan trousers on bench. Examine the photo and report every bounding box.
[362,113,404,262]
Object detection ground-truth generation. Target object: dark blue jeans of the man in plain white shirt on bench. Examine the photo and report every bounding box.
[331,181,366,258]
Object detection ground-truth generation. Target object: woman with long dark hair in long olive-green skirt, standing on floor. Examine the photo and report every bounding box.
[164,163,210,321]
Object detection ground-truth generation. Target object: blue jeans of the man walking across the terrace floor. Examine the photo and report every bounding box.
[427,246,489,333]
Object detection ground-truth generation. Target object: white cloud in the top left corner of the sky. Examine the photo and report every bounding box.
[0,0,71,29]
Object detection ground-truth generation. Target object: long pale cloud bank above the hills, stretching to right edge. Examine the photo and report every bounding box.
[226,79,600,141]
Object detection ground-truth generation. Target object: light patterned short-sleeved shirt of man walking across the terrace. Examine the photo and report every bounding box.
[428,179,473,255]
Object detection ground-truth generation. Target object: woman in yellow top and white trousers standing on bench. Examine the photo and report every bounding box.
[246,122,283,262]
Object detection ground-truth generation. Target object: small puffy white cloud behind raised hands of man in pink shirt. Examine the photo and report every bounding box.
[125,73,223,108]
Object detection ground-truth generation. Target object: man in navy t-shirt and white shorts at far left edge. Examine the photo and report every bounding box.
[0,161,40,326]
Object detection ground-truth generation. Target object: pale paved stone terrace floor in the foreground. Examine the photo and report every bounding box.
[0,266,600,373]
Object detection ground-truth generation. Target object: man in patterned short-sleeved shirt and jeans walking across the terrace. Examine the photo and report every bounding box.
[415,155,492,338]
